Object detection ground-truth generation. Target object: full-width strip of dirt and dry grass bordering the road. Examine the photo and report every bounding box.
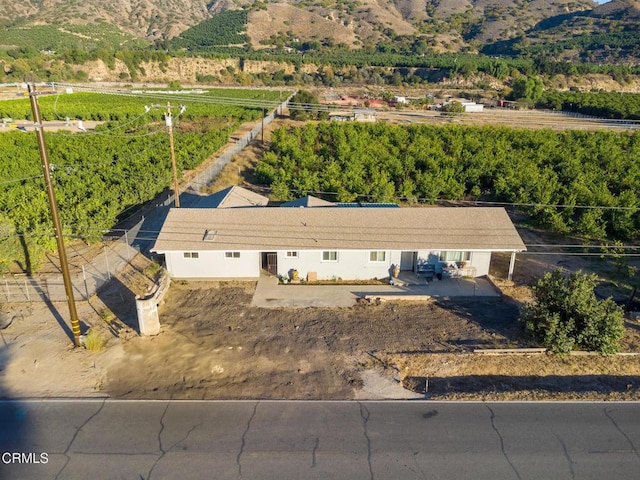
[0,272,640,400]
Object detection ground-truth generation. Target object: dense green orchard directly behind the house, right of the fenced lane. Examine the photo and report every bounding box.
[256,122,640,239]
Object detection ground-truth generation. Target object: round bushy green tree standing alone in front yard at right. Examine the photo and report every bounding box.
[520,269,624,354]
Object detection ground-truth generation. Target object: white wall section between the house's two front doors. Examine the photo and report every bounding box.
[278,250,400,280]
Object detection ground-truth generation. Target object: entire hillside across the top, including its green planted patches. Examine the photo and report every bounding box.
[0,0,640,65]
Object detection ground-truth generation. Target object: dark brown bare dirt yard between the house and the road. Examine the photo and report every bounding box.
[106,282,517,399]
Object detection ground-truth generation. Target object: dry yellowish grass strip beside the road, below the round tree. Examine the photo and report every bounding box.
[385,353,640,400]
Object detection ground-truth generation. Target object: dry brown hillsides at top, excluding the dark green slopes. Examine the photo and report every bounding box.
[0,0,600,51]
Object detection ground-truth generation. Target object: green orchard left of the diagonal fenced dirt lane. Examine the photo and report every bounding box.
[0,90,278,272]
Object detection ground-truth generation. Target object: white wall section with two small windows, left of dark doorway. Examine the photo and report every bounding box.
[165,251,260,278]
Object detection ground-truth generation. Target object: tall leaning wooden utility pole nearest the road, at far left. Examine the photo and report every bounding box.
[28,83,80,347]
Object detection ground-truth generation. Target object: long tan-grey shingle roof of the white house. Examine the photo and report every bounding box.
[152,207,526,252]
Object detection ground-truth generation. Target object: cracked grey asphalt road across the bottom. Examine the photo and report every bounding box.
[0,400,640,480]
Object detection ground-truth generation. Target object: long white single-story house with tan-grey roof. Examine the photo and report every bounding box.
[152,207,526,280]
